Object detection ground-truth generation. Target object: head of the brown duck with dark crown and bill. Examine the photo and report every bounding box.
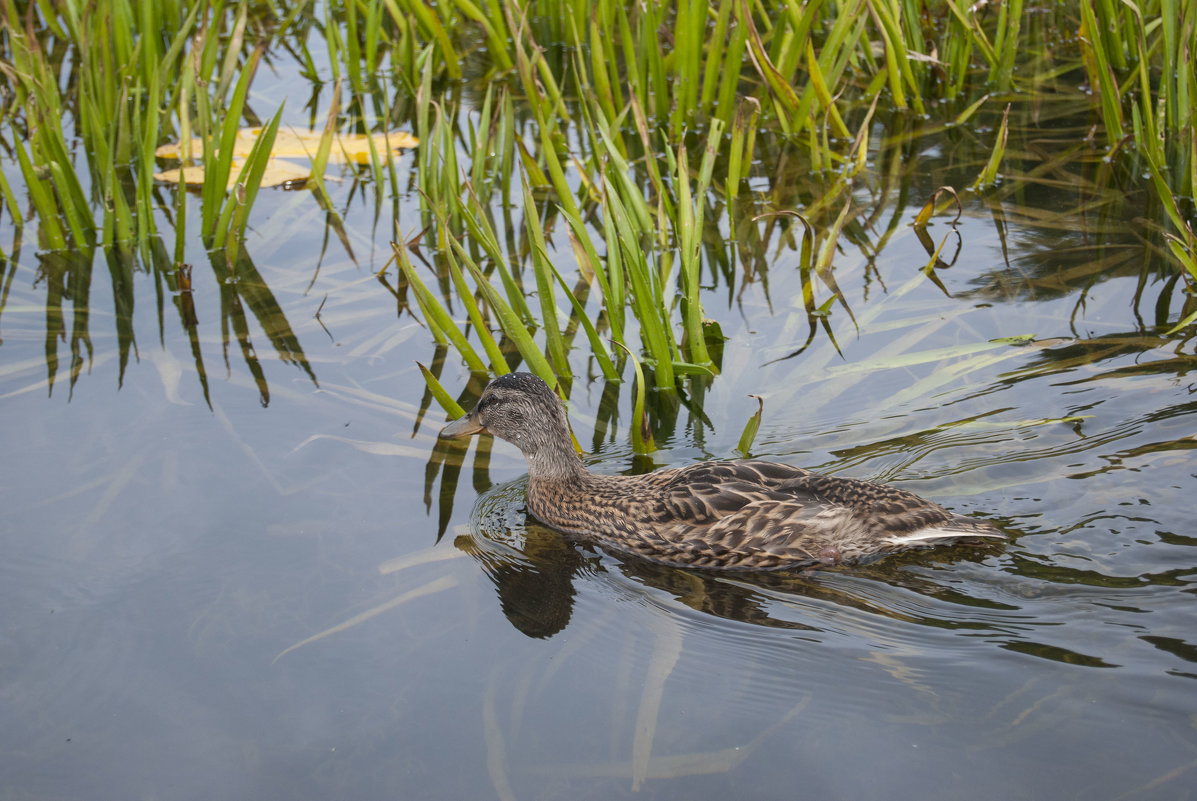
[440,372,572,460]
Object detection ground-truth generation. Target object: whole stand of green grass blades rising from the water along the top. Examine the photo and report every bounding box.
[0,0,1197,419]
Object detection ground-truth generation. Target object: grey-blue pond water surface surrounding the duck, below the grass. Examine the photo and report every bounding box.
[0,37,1197,801]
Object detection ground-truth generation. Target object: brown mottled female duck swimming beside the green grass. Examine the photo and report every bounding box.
[440,372,1005,570]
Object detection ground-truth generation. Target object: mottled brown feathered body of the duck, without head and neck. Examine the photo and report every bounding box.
[529,460,1001,570]
